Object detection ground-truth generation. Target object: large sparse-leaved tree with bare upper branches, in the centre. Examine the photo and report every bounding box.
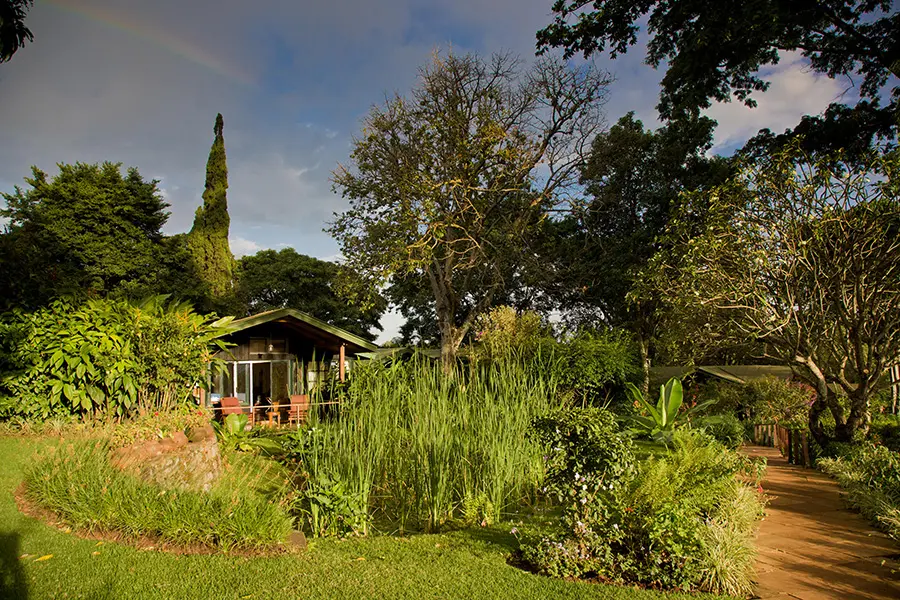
[329,54,609,368]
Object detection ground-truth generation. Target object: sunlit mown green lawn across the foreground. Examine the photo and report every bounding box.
[0,436,728,600]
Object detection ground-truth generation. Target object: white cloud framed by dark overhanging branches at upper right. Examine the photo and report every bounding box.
[706,53,845,151]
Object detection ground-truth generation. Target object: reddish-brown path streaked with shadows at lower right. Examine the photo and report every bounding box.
[746,446,900,600]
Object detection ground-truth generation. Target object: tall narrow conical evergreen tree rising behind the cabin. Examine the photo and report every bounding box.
[188,114,234,308]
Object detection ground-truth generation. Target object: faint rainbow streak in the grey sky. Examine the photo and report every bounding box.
[44,0,256,86]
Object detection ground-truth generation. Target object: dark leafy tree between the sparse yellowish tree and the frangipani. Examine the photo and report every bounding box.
[551,113,730,392]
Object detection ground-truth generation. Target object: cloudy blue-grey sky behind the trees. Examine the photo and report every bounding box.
[0,0,853,341]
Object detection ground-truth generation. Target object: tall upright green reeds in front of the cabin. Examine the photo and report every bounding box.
[293,357,558,533]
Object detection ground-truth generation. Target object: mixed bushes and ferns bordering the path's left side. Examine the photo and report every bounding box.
[522,426,762,595]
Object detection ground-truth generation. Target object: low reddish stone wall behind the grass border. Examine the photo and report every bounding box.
[110,425,222,492]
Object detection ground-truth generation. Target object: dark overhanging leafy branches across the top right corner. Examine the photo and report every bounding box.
[537,0,900,118]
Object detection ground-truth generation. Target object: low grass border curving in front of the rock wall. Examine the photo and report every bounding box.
[25,440,292,551]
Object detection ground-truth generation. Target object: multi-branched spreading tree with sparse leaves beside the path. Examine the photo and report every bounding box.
[654,143,900,442]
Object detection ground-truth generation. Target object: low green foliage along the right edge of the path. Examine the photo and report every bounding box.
[816,444,900,540]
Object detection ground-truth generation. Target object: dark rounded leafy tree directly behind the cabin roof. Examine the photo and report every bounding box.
[237,248,387,340]
